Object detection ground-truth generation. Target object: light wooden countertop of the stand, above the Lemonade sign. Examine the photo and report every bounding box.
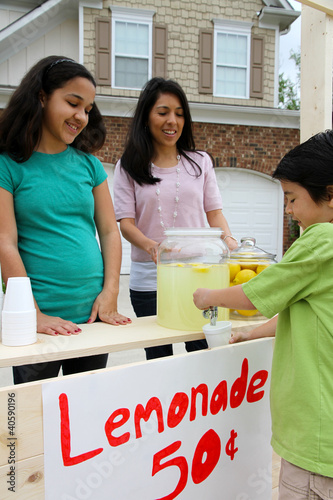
[0,316,262,367]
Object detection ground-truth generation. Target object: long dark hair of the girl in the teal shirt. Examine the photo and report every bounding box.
[0,56,106,162]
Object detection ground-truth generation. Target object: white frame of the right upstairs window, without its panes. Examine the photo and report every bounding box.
[213,19,253,99]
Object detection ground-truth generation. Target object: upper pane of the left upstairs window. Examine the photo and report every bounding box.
[115,21,149,57]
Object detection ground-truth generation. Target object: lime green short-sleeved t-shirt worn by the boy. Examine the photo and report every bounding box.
[243,223,333,477]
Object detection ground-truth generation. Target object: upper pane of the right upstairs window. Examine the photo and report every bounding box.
[216,33,247,66]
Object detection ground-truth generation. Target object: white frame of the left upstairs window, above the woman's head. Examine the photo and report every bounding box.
[110,5,155,90]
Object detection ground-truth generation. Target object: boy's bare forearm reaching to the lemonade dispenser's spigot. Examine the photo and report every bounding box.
[193,285,256,310]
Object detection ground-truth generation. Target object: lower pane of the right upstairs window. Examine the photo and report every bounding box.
[216,67,246,97]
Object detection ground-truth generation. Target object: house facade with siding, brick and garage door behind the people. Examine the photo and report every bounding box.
[0,0,299,272]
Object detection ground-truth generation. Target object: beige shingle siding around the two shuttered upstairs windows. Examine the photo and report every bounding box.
[84,0,275,107]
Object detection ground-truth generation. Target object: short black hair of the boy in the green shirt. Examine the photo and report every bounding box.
[272,130,333,204]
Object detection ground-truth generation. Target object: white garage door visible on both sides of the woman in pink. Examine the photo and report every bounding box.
[104,164,283,274]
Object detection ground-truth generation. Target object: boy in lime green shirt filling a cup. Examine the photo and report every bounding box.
[194,130,333,500]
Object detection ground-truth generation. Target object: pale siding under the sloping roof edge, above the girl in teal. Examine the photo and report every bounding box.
[0,20,79,86]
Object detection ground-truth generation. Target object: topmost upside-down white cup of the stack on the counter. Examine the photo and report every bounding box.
[3,277,35,312]
